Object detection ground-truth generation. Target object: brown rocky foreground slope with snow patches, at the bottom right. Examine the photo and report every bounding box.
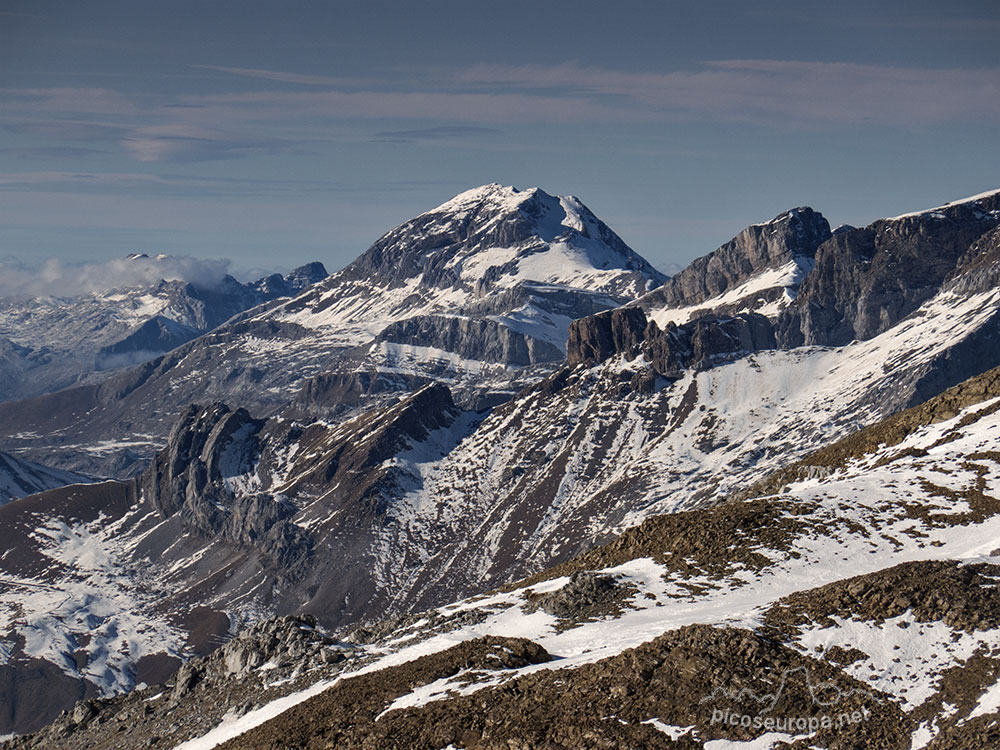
[9,362,1000,750]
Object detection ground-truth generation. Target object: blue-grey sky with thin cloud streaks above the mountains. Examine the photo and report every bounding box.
[0,0,1000,282]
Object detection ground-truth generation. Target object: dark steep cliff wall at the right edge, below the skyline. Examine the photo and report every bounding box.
[778,194,1000,347]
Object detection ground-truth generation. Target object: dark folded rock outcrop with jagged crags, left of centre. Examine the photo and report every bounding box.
[132,384,459,620]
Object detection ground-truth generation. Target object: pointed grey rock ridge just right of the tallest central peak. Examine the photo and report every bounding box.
[640,207,830,310]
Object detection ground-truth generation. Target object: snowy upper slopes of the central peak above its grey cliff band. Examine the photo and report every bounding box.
[267,184,664,364]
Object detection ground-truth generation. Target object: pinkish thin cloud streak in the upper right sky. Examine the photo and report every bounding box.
[456,60,1000,125]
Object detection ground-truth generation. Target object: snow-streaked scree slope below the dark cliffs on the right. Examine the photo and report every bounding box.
[366,268,1000,603]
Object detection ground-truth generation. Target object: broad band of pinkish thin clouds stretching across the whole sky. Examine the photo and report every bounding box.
[0,60,1000,173]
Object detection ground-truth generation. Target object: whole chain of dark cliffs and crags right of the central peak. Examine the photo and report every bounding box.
[567,194,1000,376]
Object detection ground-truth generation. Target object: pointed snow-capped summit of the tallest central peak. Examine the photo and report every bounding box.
[345,183,665,301]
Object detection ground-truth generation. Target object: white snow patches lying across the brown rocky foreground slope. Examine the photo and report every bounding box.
[178,390,1000,750]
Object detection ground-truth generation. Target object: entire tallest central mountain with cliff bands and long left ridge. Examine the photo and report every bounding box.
[0,185,664,473]
